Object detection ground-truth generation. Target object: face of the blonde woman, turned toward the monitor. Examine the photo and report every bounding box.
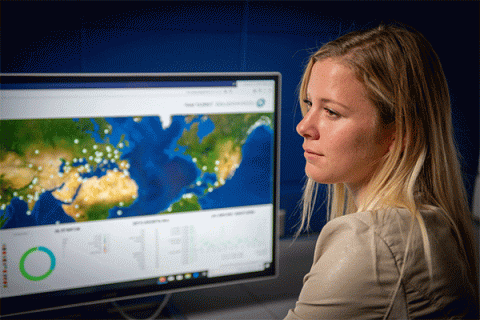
[297,59,394,194]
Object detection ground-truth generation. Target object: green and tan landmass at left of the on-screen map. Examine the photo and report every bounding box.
[0,118,138,228]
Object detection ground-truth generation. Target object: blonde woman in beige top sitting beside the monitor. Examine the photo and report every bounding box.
[286,26,479,319]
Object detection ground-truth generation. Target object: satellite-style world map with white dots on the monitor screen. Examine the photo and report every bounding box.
[0,113,274,229]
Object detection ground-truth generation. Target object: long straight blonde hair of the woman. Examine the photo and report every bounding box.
[298,25,478,312]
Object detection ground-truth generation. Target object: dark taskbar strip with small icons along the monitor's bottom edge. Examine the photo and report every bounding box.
[0,262,278,318]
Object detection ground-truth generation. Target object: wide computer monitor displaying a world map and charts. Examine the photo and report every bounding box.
[0,72,281,316]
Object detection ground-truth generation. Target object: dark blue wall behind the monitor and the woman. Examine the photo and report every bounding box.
[1,1,479,234]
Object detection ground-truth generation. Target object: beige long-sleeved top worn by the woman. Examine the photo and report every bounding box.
[285,209,478,319]
